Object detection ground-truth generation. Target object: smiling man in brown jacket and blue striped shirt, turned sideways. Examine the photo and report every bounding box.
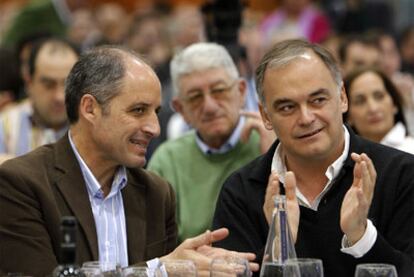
[0,47,257,277]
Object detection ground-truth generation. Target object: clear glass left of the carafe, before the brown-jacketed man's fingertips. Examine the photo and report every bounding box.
[210,256,252,277]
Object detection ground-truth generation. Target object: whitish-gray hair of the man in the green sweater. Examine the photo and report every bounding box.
[170,42,239,96]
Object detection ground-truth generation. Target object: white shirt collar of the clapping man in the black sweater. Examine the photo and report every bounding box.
[271,126,350,209]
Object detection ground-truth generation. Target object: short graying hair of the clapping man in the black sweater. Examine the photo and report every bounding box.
[256,39,342,104]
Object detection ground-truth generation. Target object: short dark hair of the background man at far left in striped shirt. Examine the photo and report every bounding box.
[29,37,80,76]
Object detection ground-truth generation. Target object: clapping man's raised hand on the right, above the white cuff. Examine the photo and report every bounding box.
[340,153,377,246]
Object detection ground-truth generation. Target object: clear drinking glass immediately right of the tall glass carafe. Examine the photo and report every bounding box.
[283,258,323,277]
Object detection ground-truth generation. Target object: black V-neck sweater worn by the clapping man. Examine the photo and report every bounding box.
[213,126,414,277]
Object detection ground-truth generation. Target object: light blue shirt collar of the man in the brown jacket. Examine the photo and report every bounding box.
[68,130,127,199]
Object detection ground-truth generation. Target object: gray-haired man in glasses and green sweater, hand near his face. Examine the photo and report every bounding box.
[148,43,274,241]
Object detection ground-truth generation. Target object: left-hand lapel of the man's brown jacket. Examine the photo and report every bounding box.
[54,134,99,260]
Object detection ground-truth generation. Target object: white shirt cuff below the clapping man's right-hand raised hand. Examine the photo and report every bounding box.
[341,219,377,258]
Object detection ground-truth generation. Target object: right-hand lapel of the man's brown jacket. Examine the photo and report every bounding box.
[122,171,147,264]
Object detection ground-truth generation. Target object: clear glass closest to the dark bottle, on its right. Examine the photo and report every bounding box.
[81,261,122,277]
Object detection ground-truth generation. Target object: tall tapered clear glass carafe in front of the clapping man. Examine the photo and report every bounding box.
[260,195,296,277]
